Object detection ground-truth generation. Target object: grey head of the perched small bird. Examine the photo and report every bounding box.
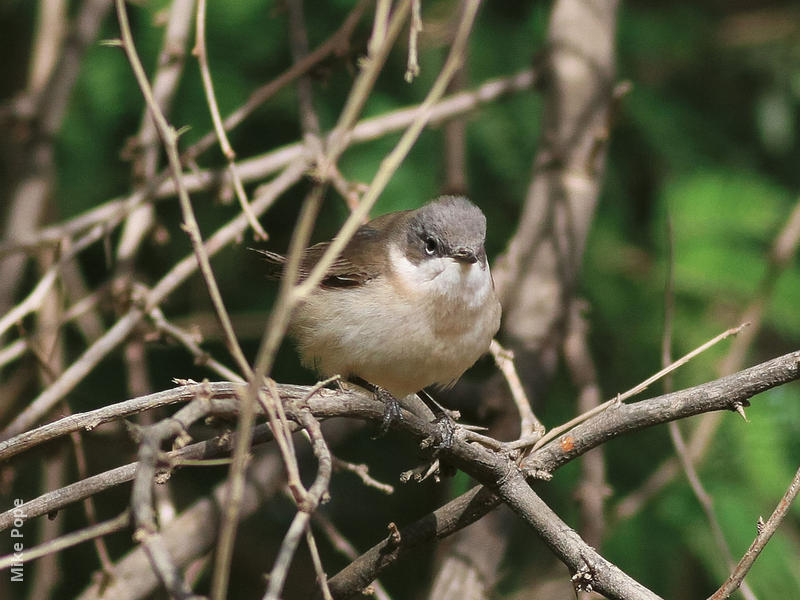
[407,196,486,264]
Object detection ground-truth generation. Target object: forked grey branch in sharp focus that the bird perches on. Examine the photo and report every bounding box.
[0,351,800,598]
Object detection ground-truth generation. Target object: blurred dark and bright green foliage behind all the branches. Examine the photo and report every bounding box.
[0,0,800,600]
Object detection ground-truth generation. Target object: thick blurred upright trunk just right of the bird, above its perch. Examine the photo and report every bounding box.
[493,0,618,396]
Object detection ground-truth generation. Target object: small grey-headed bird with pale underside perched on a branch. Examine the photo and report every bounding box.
[262,196,500,426]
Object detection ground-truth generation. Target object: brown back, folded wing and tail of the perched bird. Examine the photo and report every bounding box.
[257,211,407,288]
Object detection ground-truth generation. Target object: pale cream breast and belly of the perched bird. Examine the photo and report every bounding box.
[292,248,500,397]
